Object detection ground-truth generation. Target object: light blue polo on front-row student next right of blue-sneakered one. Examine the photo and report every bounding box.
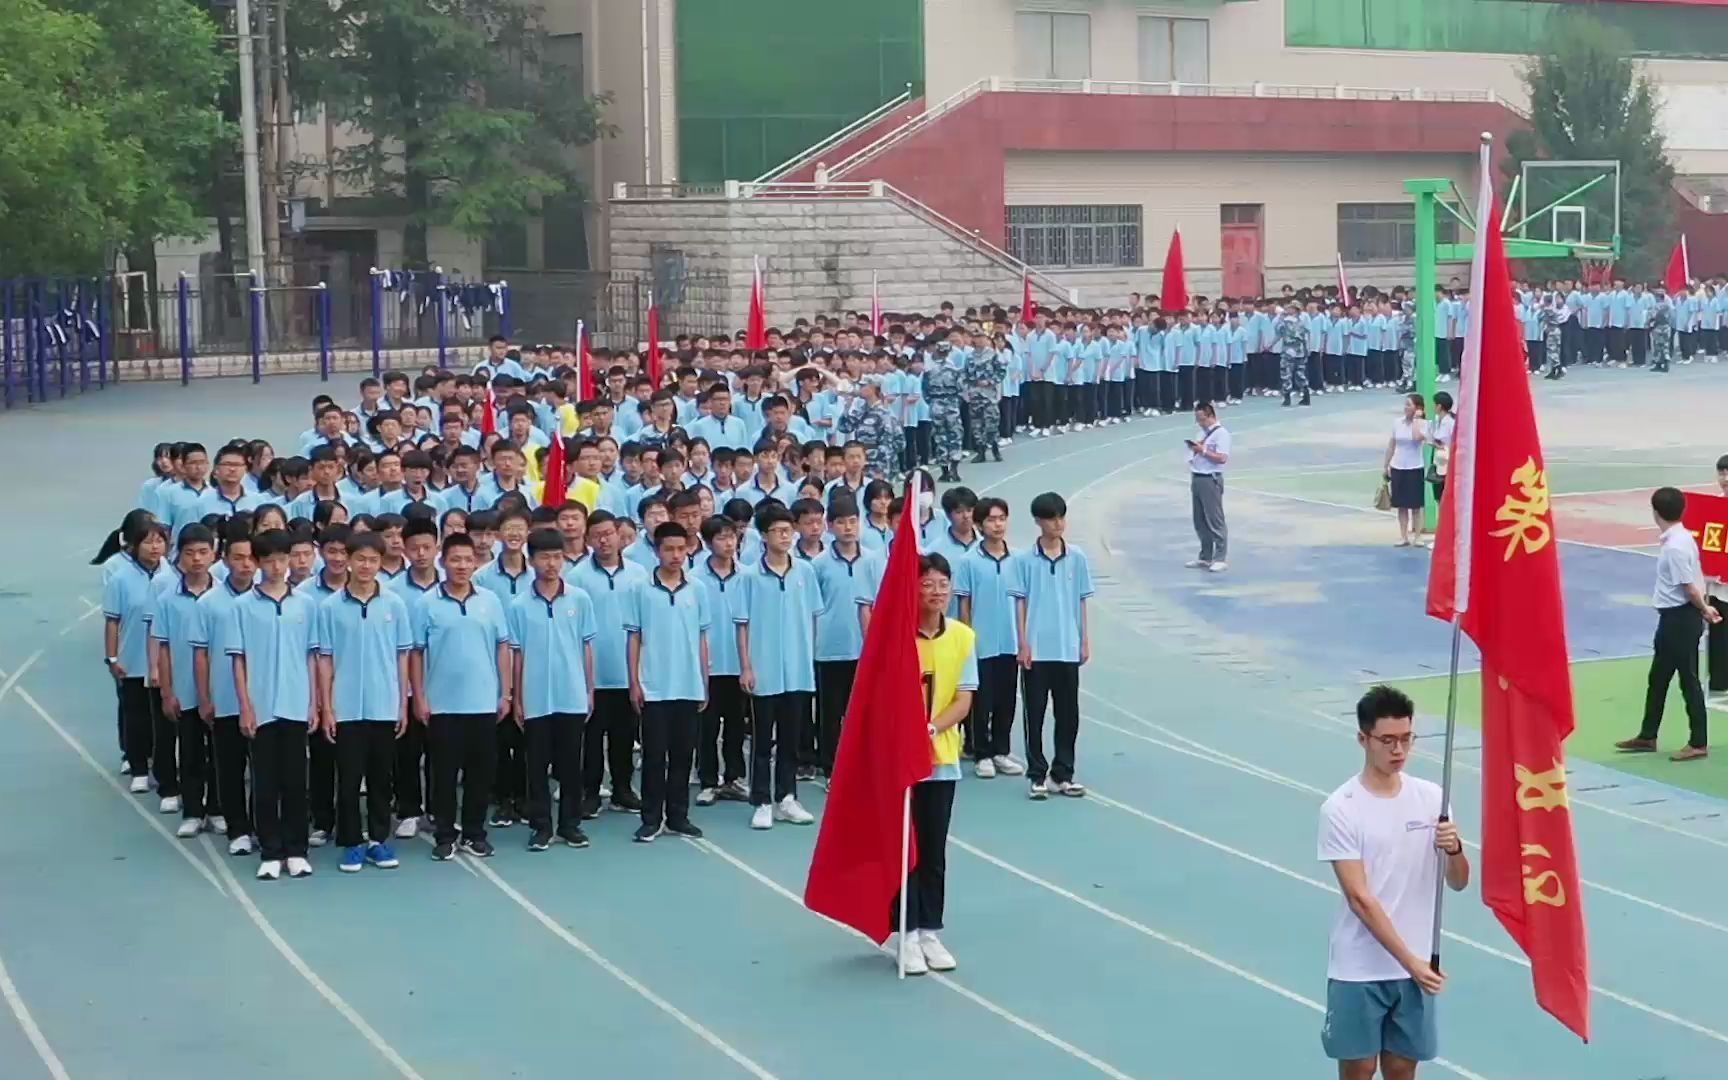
[413,584,510,714]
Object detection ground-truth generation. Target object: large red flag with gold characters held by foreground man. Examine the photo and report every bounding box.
[1427,171,1590,1039]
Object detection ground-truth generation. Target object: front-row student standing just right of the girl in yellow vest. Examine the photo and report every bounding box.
[1007,491,1092,800]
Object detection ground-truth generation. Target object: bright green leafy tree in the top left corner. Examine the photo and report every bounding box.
[0,0,228,275]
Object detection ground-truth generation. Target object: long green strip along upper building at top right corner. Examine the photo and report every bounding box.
[1284,0,1728,59]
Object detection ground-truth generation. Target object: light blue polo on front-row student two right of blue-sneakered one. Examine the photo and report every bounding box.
[505,579,598,717]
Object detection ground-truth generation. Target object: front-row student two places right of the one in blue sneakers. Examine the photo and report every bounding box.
[506,529,598,852]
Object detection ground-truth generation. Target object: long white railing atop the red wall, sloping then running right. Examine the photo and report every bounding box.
[828,76,1510,180]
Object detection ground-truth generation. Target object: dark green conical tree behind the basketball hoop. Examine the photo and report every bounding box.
[1507,12,1674,278]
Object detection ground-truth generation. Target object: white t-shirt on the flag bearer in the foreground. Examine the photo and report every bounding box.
[1320,776,1441,983]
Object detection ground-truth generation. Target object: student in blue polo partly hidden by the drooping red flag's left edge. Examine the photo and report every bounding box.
[810,494,886,785]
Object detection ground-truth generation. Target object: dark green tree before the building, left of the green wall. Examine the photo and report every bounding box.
[289,0,612,266]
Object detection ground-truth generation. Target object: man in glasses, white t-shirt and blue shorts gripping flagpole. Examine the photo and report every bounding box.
[1320,686,1471,1080]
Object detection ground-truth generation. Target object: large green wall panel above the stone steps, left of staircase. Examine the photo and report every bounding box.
[677,0,924,183]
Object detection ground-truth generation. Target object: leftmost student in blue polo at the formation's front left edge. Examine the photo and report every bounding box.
[102,515,170,794]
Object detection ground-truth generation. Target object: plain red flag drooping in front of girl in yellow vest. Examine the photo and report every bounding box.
[804,480,930,945]
